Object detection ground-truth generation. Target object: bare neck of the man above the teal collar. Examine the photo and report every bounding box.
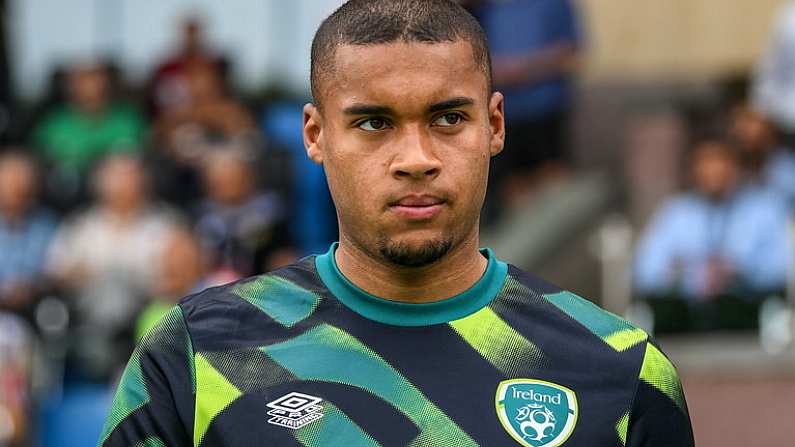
[335,231,488,303]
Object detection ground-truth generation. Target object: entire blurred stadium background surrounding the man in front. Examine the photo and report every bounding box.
[0,0,795,447]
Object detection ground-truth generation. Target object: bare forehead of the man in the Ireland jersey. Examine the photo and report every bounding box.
[323,40,488,111]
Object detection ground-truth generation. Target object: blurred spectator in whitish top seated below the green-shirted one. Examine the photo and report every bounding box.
[48,154,180,382]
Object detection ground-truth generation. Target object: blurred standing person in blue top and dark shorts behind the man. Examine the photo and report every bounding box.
[471,0,582,208]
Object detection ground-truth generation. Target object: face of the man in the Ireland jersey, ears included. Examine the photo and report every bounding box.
[304,41,504,266]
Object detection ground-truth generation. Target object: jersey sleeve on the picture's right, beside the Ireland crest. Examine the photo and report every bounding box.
[619,342,695,447]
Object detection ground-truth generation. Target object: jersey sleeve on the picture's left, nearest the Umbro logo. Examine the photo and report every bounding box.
[99,306,196,447]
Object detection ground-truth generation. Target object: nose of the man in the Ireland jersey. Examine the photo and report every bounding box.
[391,126,442,180]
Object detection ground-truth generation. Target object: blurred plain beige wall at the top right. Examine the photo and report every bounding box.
[579,0,787,80]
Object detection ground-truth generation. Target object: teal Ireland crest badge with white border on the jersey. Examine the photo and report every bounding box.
[495,379,577,447]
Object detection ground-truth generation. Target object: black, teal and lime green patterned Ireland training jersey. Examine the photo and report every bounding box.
[100,247,693,447]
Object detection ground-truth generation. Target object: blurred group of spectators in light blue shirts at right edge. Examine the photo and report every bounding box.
[632,3,795,332]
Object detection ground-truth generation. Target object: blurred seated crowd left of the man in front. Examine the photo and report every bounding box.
[0,18,336,446]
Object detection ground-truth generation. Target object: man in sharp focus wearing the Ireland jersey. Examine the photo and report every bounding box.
[100,0,692,447]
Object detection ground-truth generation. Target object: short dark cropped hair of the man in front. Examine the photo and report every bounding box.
[311,0,491,104]
